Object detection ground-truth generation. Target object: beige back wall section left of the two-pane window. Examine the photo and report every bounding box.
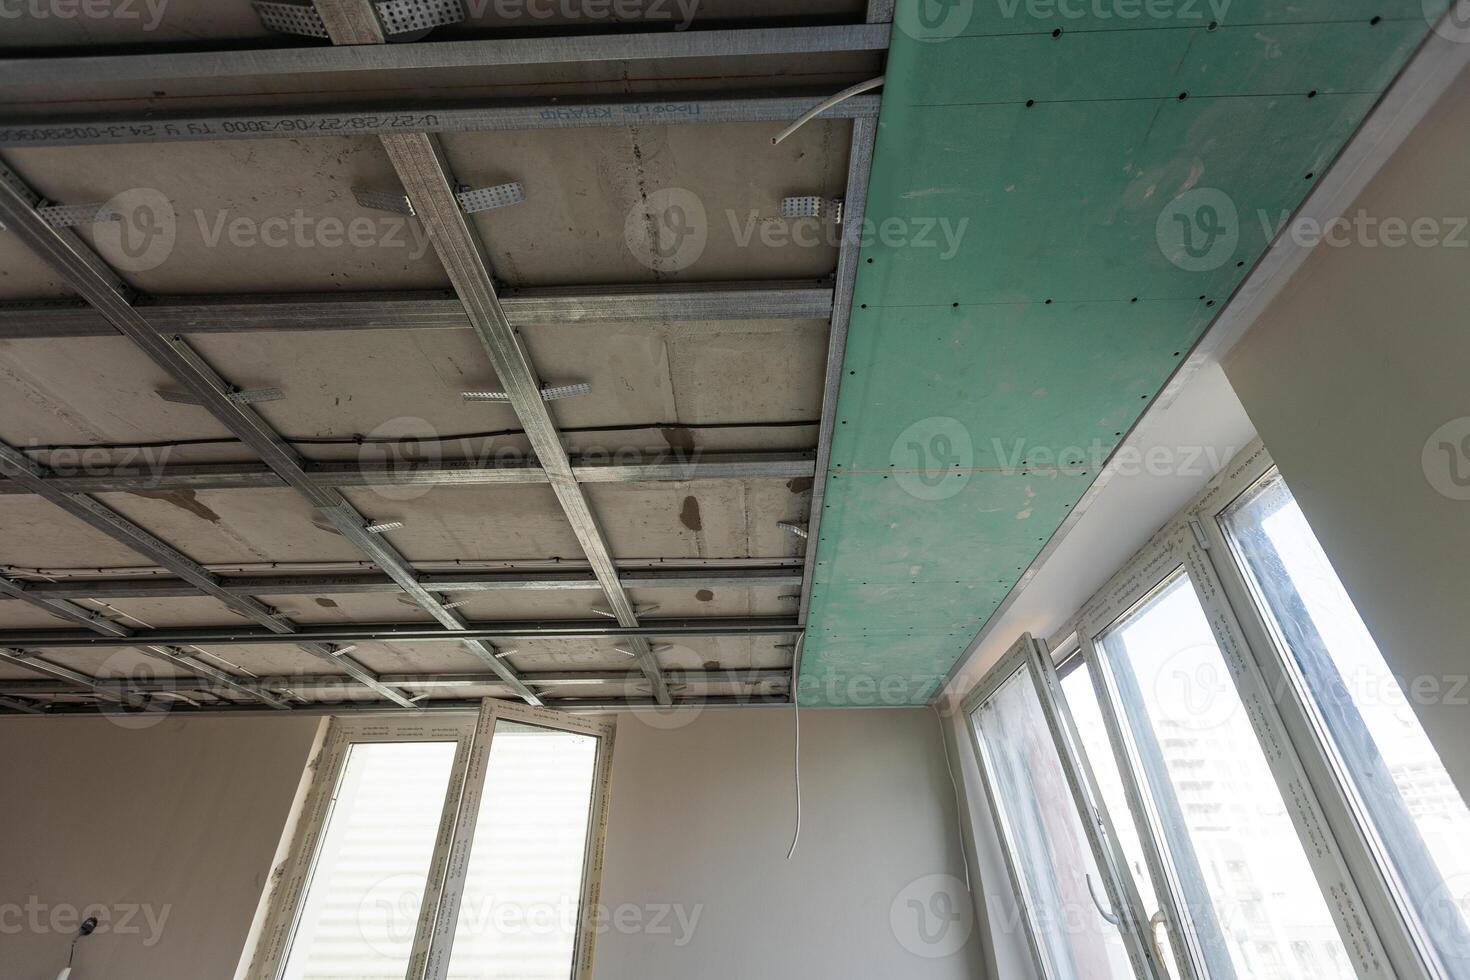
[0,717,318,980]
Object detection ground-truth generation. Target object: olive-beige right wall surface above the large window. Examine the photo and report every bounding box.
[1225,61,1470,796]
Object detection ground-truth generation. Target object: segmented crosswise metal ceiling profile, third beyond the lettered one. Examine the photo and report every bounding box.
[0,566,801,599]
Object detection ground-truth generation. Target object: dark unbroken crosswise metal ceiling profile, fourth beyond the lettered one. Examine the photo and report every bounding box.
[0,616,801,646]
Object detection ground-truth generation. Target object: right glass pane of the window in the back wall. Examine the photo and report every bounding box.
[450,720,597,980]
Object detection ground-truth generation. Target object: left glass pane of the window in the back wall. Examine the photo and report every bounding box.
[281,742,457,980]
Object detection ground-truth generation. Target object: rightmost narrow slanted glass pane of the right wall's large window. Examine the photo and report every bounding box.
[1222,473,1470,979]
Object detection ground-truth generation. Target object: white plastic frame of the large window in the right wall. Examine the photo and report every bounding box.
[961,441,1448,980]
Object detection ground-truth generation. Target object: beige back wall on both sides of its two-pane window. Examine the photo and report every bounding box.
[0,710,980,980]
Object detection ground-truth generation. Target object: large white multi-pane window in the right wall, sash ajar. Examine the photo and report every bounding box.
[966,447,1470,980]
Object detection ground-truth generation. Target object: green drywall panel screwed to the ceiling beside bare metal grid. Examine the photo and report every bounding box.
[800,0,1448,705]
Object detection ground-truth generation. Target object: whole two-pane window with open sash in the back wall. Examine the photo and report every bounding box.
[247,701,612,980]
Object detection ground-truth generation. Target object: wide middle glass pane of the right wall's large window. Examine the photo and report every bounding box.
[1100,572,1355,980]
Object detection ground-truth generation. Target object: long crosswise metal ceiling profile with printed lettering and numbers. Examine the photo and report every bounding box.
[0,91,878,148]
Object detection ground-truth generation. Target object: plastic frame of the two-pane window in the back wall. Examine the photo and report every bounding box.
[244,698,616,980]
